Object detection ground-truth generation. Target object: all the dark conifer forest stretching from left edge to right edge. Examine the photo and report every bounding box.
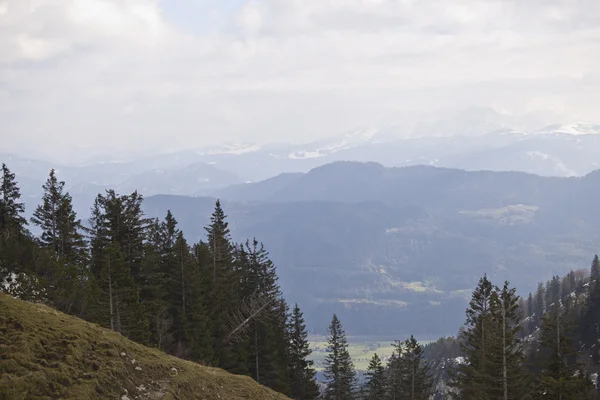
[0,164,600,400]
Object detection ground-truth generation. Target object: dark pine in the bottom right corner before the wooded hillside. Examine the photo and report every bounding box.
[535,305,593,400]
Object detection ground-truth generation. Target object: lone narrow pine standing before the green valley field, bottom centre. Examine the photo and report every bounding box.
[324,314,356,400]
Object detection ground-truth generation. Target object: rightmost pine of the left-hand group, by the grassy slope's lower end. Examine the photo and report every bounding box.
[287,304,319,400]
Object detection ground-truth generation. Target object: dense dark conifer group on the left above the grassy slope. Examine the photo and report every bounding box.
[0,164,319,400]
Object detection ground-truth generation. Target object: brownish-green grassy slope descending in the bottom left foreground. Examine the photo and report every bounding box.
[0,294,286,400]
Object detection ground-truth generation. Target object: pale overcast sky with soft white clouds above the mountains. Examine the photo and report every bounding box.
[0,0,600,159]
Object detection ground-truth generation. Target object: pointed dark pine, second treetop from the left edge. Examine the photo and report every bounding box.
[31,169,86,264]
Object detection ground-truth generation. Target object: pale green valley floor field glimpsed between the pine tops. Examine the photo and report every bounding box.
[309,336,428,371]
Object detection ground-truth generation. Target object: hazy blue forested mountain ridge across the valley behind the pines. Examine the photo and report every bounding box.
[145,162,600,336]
